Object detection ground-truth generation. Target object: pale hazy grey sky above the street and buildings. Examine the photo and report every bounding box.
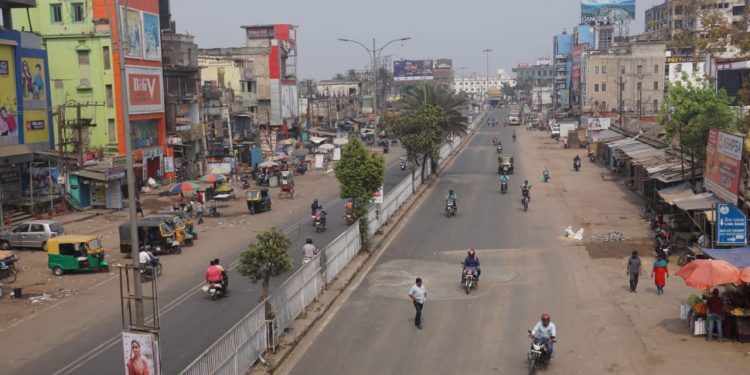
[171,0,663,79]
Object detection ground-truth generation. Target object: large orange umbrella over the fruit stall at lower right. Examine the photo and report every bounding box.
[675,259,740,290]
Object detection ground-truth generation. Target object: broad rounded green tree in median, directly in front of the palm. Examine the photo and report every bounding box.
[393,104,448,180]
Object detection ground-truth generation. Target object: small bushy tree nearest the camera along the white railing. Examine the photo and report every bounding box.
[237,227,294,317]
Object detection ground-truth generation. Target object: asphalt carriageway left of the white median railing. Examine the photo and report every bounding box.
[8,142,418,374]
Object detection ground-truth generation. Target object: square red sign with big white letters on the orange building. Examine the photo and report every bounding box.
[125,66,164,114]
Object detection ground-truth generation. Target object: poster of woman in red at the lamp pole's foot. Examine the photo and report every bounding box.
[122,332,161,375]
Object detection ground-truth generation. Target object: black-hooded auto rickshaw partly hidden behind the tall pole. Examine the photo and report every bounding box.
[119,219,182,254]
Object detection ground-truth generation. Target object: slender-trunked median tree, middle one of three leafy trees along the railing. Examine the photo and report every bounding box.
[335,137,385,249]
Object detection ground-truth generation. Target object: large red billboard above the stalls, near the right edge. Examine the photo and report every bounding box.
[703,129,745,203]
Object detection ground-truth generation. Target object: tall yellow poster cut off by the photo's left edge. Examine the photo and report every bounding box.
[0,45,18,145]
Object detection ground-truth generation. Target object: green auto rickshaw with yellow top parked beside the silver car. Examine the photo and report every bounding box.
[47,235,109,276]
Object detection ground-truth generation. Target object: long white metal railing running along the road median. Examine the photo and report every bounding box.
[181,113,486,375]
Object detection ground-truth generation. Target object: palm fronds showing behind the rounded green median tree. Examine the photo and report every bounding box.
[401,83,468,136]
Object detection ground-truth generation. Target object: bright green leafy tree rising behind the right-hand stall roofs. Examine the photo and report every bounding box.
[657,82,736,176]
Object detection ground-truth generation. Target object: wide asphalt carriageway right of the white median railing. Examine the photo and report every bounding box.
[282,107,585,375]
